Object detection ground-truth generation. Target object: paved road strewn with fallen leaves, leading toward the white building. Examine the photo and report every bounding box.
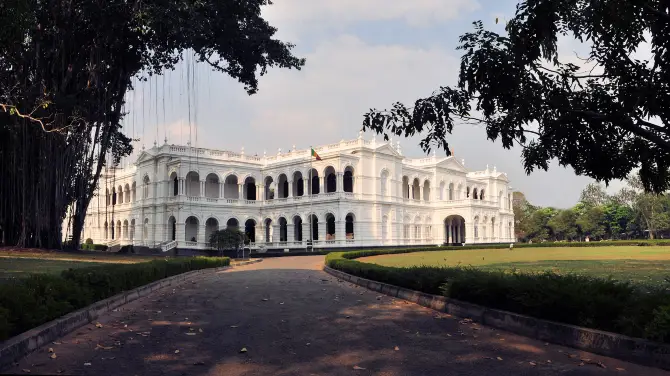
[9,256,670,376]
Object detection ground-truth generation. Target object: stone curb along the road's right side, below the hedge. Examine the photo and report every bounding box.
[323,266,670,370]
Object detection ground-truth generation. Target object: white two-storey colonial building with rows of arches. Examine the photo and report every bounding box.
[83,136,514,250]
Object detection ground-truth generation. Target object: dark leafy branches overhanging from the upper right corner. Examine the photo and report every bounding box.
[363,0,670,192]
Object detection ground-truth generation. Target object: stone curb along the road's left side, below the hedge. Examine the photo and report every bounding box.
[0,259,262,371]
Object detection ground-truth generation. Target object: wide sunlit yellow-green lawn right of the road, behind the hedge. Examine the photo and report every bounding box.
[357,246,670,285]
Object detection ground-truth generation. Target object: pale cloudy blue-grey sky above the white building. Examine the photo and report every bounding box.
[124,0,623,208]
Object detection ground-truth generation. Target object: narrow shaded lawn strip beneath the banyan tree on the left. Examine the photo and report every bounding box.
[0,248,165,283]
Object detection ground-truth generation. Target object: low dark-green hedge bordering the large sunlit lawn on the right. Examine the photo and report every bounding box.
[326,250,670,343]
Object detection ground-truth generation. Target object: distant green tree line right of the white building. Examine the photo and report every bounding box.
[513,175,670,242]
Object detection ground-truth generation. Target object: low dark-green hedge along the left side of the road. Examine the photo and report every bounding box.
[0,257,230,340]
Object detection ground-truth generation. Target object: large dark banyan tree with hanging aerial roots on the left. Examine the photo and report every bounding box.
[0,0,304,248]
